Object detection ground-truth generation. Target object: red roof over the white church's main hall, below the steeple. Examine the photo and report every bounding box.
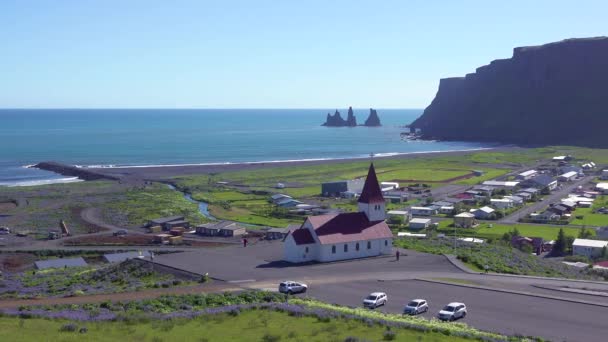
[308,213,393,244]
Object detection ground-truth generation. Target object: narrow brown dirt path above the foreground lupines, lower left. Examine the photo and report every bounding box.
[0,281,243,309]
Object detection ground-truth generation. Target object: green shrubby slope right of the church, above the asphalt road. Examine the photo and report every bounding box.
[394,238,599,279]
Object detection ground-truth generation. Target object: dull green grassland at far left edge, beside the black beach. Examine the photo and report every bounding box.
[0,181,126,238]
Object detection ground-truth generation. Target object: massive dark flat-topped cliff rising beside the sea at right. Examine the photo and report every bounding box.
[410,37,608,147]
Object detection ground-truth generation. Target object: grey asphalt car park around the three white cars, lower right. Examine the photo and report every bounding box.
[307,280,608,341]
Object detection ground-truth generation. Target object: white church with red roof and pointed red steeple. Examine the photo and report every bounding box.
[284,164,393,263]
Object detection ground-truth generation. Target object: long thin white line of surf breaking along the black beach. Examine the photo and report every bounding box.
[74,147,496,169]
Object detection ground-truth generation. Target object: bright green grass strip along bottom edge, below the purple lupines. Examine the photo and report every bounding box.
[0,310,480,342]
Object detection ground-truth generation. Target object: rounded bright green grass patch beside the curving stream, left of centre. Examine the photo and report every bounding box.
[104,183,208,227]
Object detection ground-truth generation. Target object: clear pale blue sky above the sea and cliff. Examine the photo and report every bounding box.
[0,0,608,108]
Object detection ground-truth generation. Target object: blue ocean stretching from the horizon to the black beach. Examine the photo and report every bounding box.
[0,109,490,185]
